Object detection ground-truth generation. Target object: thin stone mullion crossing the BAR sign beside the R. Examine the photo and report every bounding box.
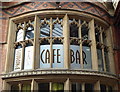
[78,20,83,68]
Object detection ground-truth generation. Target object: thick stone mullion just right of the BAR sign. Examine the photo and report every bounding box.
[89,19,98,70]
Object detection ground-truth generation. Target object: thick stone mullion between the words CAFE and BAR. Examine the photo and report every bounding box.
[63,14,70,69]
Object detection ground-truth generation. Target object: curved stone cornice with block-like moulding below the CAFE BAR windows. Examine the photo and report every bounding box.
[1,69,117,79]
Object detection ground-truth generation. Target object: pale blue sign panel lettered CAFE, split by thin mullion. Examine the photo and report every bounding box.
[40,44,64,68]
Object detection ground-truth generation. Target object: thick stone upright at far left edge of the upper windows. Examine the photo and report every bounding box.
[5,20,17,73]
